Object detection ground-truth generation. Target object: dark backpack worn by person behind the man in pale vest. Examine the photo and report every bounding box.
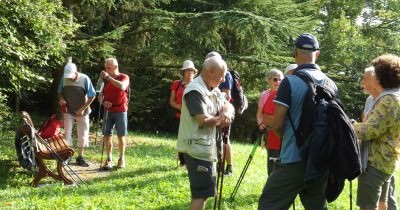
[229,70,249,114]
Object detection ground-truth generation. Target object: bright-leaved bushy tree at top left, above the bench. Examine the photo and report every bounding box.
[0,0,77,120]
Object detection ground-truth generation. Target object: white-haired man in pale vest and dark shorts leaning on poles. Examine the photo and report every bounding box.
[176,56,234,209]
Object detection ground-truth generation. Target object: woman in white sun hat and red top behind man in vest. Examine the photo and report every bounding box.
[169,60,197,166]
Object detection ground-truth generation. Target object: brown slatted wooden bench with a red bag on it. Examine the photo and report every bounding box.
[21,112,74,187]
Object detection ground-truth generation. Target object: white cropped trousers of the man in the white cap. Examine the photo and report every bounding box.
[64,113,89,148]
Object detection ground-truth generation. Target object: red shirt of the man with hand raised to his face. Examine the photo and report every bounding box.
[103,73,129,112]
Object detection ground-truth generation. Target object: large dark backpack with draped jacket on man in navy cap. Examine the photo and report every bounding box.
[288,71,361,202]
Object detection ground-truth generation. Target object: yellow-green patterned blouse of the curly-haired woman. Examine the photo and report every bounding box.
[354,94,400,174]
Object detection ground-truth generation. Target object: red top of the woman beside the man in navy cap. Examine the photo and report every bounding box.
[262,90,281,150]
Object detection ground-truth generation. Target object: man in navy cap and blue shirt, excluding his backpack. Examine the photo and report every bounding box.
[258,33,337,210]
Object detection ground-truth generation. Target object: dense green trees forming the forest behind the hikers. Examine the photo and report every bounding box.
[0,0,400,141]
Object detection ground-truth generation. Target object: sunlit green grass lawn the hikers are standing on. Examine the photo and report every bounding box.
[0,130,400,210]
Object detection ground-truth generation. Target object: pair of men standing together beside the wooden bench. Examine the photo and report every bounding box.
[58,58,129,169]
